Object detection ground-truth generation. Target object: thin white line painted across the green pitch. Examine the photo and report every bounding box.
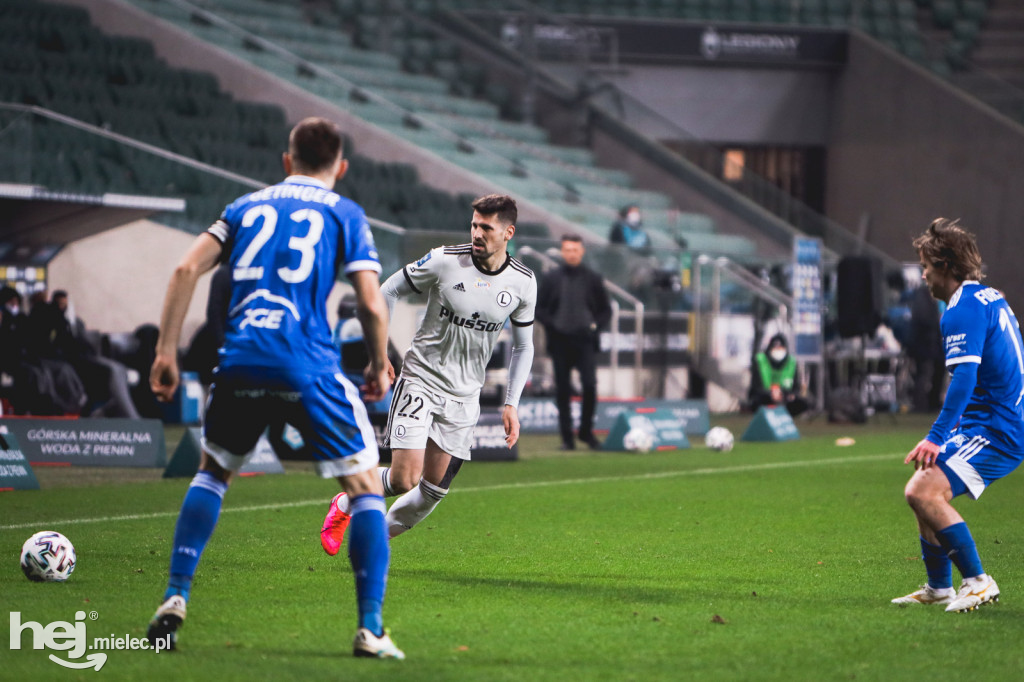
[0,453,902,530]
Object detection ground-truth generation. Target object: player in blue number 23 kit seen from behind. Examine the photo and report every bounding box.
[147,119,404,658]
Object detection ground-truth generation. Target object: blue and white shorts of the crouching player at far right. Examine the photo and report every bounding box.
[937,428,1021,500]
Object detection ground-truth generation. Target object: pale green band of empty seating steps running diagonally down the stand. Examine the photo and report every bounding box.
[112,0,756,258]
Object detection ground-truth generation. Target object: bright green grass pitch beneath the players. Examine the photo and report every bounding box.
[0,417,1024,681]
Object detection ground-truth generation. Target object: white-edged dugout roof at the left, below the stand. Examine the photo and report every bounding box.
[0,182,185,245]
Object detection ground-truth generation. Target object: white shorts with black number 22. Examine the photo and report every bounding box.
[383,377,480,460]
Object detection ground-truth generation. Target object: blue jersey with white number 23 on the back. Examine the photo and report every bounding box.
[208,175,381,374]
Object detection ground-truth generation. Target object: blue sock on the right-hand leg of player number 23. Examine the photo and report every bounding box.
[348,495,391,637]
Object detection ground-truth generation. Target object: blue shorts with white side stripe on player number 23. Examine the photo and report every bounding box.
[203,367,379,478]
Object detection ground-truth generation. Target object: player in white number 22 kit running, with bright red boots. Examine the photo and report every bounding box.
[321,195,537,556]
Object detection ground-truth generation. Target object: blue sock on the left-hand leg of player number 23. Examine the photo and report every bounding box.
[164,471,227,601]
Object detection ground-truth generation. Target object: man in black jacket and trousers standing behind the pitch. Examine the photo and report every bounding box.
[537,235,611,450]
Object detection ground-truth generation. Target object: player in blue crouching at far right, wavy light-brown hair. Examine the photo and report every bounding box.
[893,218,1024,611]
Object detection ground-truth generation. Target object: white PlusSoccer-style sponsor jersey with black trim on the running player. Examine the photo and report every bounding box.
[402,244,537,399]
